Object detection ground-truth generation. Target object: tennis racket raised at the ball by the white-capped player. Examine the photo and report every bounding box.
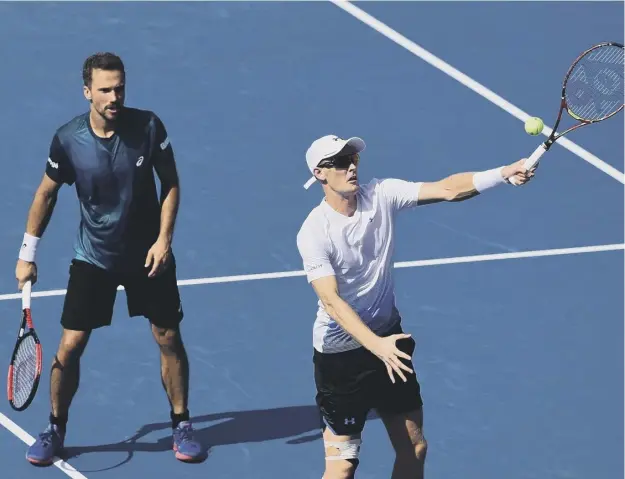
[510,42,625,184]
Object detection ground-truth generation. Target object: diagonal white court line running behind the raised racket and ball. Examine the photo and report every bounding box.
[330,0,625,184]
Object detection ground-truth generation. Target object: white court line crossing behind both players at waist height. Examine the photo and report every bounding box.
[0,244,625,301]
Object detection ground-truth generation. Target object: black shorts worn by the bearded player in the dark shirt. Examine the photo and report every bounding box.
[61,258,184,331]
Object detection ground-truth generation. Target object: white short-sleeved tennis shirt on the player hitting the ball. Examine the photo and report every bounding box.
[297,179,421,353]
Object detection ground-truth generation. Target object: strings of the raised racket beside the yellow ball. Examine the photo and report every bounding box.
[565,45,625,121]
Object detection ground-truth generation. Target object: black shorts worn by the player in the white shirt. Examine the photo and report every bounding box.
[313,325,423,436]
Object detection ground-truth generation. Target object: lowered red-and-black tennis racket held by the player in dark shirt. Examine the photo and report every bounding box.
[7,281,42,411]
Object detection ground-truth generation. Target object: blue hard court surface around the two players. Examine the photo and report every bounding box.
[0,2,624,479]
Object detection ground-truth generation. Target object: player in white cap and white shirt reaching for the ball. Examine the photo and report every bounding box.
[297,135,535,479]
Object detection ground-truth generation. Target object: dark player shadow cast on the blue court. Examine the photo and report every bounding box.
[63,406,377,471]
